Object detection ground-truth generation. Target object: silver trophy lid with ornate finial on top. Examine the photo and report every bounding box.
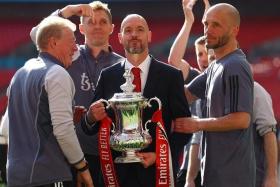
[109,69,146,102]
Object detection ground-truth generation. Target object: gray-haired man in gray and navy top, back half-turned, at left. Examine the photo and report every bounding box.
[7,16,93,187]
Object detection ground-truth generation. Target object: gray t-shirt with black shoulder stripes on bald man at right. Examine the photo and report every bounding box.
[188,49,256,187]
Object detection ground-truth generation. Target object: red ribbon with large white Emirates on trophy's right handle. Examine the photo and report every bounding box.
[151,109,174,187]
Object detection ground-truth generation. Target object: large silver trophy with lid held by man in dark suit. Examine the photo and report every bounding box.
[102,70,161,163]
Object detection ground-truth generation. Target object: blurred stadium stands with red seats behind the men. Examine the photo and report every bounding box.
[0,0,280,122]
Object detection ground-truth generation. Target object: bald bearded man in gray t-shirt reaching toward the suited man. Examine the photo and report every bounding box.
[174,3,256,187]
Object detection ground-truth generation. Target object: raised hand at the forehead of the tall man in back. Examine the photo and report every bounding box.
[61,4,93,18]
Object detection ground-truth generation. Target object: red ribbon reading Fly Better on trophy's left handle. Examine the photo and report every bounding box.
[98,117,119,187]
